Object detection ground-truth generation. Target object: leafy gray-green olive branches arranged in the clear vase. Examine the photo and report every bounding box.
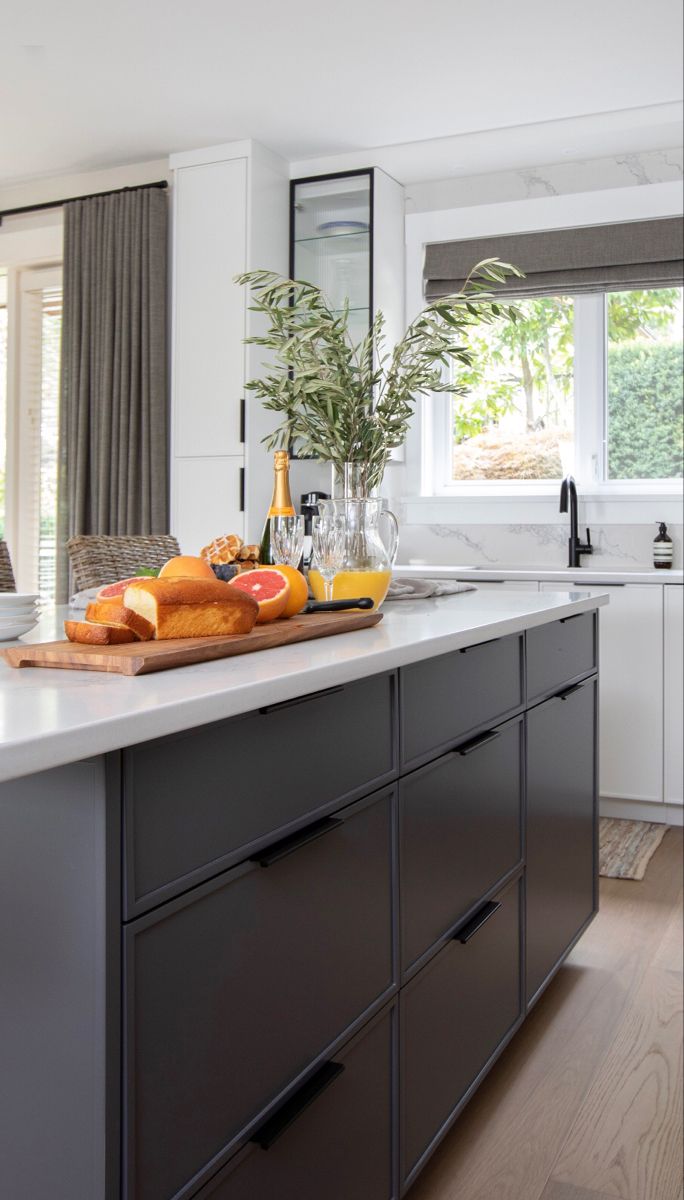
[235,258,522,488]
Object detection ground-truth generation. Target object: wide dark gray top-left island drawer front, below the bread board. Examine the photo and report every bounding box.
[124,674,396,917]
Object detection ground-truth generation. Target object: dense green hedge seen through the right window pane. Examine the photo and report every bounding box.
[608,342,684,479]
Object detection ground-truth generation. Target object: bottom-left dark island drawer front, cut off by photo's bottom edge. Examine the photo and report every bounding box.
[192,1010,396,1200]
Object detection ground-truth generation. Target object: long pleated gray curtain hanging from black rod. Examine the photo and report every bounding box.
[58,187,169,601]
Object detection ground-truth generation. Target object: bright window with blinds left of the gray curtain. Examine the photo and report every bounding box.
[0,268,61,599]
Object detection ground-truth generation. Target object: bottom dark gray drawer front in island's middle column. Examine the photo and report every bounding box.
[400,880,521,1181]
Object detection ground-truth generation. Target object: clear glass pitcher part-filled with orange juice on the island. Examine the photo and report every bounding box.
[308,498,398,608]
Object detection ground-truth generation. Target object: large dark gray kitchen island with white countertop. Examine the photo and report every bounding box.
[0,592,605,1200]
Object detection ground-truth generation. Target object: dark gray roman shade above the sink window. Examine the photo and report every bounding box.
[424,217,684,300]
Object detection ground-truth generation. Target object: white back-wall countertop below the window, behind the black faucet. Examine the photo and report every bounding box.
[394,562,684,588]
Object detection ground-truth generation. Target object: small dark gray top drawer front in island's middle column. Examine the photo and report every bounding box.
[400,635,523,764]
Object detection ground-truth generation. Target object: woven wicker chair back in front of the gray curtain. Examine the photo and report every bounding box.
[66,534,180,592]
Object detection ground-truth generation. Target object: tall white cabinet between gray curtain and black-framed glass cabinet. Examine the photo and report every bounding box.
[170,142,289,553]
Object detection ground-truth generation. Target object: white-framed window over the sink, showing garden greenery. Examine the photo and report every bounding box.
[434,287,684,493]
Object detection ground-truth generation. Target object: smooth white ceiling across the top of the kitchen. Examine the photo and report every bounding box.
[0,0,683,186]
